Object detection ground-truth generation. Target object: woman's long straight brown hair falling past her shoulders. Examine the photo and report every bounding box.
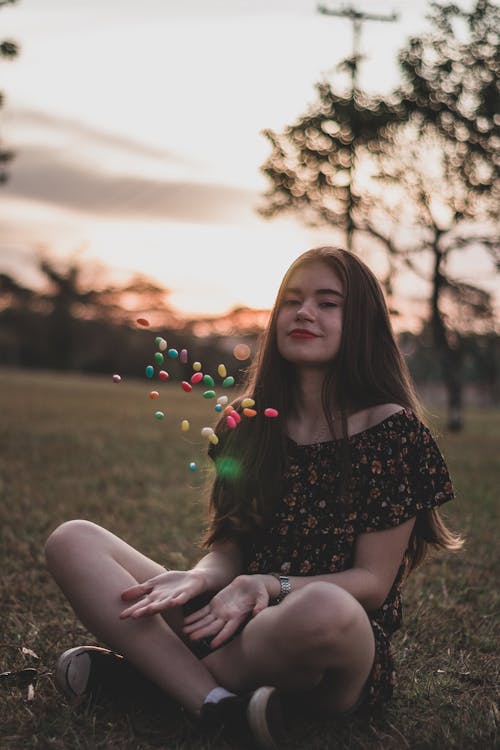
[205,246,459,567]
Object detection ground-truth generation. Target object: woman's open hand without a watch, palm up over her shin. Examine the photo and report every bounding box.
[120,570,207,619]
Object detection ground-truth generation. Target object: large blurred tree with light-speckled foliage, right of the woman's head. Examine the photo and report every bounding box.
[261,0,500,429]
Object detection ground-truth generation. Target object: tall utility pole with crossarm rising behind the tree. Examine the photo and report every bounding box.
[317,4,398,250]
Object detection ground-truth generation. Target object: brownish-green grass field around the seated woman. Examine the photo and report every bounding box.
[0,370,500,750]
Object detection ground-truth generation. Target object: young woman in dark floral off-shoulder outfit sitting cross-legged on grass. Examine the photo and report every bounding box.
[46,247,461,748]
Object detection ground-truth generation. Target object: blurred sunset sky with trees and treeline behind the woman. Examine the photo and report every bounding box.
[0,0,500,430]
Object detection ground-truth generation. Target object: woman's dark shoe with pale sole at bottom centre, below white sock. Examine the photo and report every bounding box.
[200,686,285,750]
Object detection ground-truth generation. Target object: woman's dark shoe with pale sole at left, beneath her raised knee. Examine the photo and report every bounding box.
[55,646,161,703]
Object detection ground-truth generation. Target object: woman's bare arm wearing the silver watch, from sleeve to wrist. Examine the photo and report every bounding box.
[262,518,415,612]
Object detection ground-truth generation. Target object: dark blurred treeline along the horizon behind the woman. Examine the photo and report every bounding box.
[0,261,500,404]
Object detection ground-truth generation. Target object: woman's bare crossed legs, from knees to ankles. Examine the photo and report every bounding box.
[46,521,375,715]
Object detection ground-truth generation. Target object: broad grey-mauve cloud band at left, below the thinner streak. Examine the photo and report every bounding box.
[2,145,257,223]
